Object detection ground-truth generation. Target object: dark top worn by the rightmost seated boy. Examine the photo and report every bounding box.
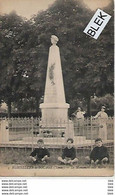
[90,146,109,161]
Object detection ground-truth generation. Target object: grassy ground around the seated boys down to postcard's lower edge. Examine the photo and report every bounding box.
[0,148,114,177]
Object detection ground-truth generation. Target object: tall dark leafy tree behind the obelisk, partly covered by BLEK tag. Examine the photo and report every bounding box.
[31,0,113,115]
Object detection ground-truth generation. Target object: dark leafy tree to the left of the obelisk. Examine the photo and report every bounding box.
[0,12,44,117]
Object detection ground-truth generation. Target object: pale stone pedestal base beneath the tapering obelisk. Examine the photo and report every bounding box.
[40,103,74,138]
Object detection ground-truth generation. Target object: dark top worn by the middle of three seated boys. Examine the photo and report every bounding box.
[62,147,76,160]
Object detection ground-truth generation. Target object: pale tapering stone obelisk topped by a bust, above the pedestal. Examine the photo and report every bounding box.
[44,35,65,104]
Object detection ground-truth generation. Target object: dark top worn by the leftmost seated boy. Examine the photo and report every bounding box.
[30,148,50,160]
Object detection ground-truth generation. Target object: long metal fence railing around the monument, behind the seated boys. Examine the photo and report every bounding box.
[0,117,114,146]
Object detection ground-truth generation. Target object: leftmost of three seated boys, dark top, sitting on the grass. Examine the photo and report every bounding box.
[30,139,50,163]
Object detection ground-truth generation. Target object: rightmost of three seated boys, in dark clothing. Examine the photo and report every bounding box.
[86,138,109,165]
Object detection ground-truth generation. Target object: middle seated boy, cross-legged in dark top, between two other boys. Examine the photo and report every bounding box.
[58,138,78,165]
